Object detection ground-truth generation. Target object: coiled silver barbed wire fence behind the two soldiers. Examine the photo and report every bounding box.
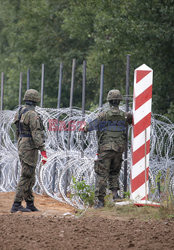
[0,105,174,208]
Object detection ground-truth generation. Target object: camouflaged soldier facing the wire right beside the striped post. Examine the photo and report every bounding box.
[84,89,132,208]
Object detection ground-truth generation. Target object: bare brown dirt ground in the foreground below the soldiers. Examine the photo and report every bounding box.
[0,193,174,250]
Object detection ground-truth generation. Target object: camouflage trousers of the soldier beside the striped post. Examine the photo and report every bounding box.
[94,150,122,200]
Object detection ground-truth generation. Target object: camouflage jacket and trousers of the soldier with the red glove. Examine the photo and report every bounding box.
[14,105,45,202]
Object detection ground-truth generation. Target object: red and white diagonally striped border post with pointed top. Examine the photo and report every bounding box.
[131,64,153,201]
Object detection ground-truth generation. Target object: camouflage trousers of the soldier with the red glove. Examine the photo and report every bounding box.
[14,160,36,202]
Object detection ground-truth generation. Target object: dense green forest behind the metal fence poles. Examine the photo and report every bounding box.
[0,0,174,121]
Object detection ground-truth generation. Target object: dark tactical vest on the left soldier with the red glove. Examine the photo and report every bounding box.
[17,107,32,137]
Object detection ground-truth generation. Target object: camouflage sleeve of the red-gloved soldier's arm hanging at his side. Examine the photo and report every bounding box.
[29,111,45,151]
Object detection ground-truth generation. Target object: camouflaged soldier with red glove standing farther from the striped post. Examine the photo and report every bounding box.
[11,89,47,213]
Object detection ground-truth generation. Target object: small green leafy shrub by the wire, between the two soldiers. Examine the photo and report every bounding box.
[72,177,94,206]
